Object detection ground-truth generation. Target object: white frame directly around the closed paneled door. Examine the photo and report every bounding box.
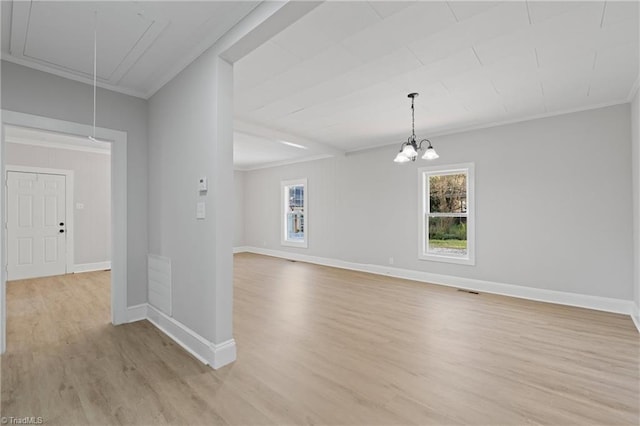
[3,164,75,274]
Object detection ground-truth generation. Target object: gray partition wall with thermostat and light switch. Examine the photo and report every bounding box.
[149,49,234,343]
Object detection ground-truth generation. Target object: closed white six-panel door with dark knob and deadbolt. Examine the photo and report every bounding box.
[7,172,67,280]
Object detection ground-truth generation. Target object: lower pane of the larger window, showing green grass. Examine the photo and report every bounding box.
[427,217,467,257]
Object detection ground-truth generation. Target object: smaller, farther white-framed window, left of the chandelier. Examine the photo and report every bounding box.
[281,179,309,248]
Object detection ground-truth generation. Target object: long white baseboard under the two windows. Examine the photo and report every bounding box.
[244,247,634,315]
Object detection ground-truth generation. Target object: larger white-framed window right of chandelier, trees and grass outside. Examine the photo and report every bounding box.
[418,163,475,265]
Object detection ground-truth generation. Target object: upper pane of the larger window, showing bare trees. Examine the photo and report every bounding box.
[429,173,467,213]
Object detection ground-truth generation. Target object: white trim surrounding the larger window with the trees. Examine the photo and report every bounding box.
[418,163,476,265]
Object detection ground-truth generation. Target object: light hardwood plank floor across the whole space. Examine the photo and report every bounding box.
[1,254,640,425]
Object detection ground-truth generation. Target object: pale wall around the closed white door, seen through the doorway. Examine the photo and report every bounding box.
[4,143,111,265]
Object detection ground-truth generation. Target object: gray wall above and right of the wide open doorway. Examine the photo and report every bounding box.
[1,61,148,306]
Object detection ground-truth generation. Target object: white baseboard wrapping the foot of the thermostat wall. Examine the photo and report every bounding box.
[127,303,236,370]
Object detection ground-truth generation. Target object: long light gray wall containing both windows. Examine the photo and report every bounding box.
[244,104,633,300]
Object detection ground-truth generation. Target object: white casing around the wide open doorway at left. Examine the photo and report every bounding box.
[0,109,127,353]
